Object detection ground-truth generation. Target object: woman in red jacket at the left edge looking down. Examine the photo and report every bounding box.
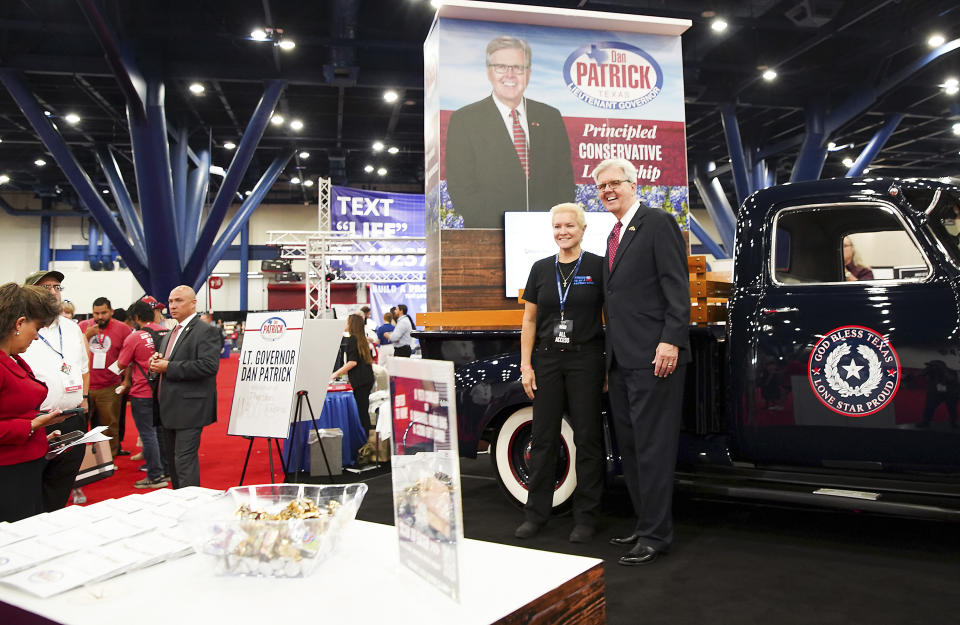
[0,282,66,522]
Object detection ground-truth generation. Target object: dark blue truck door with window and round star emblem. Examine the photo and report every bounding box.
[740,200,960,471]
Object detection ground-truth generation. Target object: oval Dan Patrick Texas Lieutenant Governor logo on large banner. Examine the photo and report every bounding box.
[563,41,663,109]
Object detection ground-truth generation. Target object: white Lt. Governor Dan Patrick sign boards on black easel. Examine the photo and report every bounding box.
[227,310,343,438]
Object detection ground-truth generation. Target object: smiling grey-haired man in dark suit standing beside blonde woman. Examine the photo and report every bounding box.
[593,159,690,566]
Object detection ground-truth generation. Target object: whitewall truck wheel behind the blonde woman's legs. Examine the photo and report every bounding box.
[490,406,577,512]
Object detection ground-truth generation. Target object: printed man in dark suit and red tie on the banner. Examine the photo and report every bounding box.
[446,37,575,228]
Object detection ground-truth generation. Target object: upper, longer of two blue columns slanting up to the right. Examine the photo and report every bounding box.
[183,80,286,284]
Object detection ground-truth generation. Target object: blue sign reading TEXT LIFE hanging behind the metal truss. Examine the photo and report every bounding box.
[330,186,426,271]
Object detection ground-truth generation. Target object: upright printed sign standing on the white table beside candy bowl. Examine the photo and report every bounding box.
[387,358,463,601]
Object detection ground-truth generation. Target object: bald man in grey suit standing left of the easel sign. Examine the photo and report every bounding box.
[150,285,220,488]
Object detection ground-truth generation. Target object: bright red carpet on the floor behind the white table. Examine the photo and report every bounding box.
[75,354,283,503]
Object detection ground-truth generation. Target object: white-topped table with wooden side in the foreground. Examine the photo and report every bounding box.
[0,521,606,625]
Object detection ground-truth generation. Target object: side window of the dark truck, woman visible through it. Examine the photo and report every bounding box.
[771,204,928,284]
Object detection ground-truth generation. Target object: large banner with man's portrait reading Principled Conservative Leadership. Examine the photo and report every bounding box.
[436,11,688,229]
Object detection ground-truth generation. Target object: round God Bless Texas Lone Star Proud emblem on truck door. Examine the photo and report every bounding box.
[807,326,900,417]
